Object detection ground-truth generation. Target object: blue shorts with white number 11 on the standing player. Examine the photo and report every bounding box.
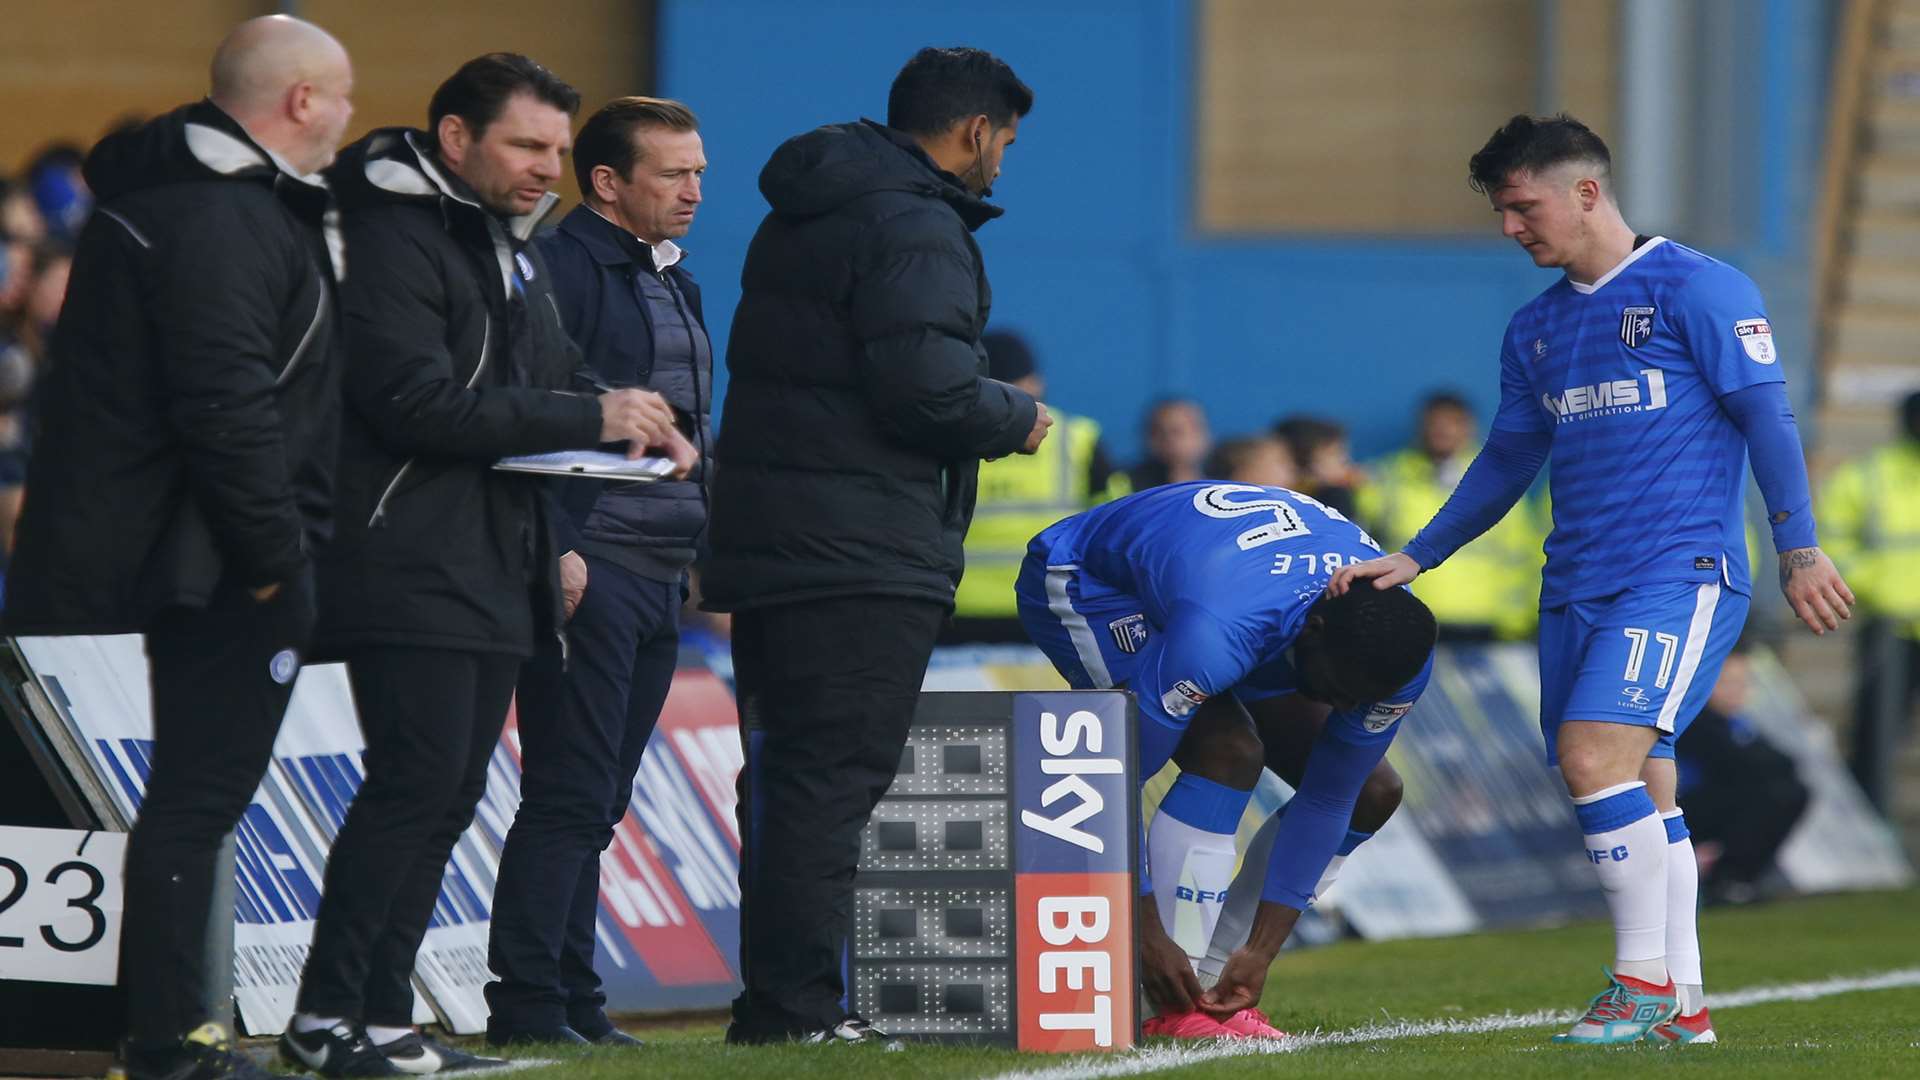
[1540,582,1747,765]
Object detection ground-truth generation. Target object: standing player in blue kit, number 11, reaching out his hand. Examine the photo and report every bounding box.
[1329,115,1853,1045]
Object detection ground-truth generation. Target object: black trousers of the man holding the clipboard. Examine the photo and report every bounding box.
[298,648,520,1026]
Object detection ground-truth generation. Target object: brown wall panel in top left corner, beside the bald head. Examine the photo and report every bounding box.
[0,0,273,173]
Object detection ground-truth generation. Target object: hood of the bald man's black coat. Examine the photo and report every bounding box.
[81,100,324,204]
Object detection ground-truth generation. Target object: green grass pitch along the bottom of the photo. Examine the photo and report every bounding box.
[424,890,1920,1080]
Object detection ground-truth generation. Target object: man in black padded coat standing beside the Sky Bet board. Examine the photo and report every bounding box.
[703,48,1050,1042]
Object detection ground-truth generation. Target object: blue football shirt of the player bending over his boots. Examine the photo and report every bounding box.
[1021,480,1432,909]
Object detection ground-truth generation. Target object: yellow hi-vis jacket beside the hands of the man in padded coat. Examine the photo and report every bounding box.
[954,411,1127,619]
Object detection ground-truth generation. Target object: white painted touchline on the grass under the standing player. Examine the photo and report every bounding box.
[991,967,1920,1080]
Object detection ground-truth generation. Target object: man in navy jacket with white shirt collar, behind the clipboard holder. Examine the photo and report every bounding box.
[488,98,712,1043]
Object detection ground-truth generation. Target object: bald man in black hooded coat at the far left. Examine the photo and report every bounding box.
[4,15,353,1080]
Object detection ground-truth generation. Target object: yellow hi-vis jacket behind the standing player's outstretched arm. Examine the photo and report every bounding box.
[1354,448,1548,638]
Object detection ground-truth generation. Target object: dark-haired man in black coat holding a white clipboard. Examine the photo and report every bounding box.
[280,54,691,1076]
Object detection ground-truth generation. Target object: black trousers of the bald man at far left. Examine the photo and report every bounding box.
[119,580,313,1049]
